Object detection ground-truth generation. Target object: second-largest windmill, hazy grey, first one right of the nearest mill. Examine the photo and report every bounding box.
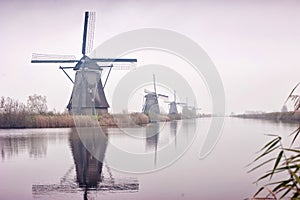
[143,74,168,115]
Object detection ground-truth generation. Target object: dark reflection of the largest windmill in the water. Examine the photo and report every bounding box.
[32,128,139,199]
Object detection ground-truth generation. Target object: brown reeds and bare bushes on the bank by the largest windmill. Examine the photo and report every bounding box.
[0,95,149,128]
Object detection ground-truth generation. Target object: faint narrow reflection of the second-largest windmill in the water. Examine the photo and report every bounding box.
[146,123,159,164]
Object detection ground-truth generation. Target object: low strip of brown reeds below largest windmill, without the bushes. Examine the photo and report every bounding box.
[0,113,155,129]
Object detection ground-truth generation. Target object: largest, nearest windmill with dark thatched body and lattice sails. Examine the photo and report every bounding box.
[31,12,137,115]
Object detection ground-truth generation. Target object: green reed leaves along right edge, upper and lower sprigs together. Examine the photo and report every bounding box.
[249,83,300,200]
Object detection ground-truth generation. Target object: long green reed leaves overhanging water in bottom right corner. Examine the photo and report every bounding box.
[249,133,300,199]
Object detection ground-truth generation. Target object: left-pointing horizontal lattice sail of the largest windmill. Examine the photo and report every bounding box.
[31,53,79,63]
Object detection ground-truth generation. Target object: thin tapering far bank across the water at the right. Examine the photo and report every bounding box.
[232,111,300,122]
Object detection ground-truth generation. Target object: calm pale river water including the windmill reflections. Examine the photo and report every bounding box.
[0,118,297,200]
